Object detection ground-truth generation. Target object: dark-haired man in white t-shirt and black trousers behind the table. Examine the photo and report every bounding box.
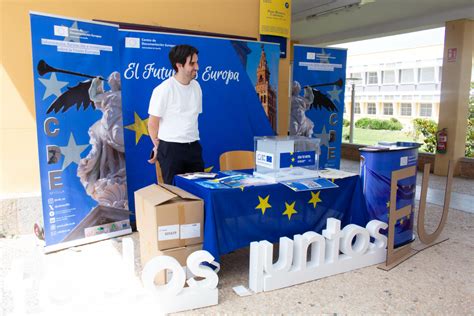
[148,45,204,184]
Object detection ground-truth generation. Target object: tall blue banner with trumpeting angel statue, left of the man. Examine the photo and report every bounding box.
[30,13,131,252]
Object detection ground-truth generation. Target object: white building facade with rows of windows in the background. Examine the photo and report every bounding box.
[344,45,443,131]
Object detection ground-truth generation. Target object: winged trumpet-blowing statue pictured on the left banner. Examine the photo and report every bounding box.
[38,60,129,241]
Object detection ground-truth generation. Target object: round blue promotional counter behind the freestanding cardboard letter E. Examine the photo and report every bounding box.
[359,142,420,247]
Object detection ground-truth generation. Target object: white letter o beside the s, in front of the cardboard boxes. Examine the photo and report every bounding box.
[142,256,186,296]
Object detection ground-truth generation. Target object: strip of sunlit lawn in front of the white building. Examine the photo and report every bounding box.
[342,127,416,145]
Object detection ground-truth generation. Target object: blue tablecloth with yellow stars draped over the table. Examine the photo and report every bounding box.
[174,174,369,261]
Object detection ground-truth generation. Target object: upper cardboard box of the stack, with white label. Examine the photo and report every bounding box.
[135,184,204,261]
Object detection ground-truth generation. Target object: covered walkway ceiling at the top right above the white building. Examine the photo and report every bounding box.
[291,0,474,45]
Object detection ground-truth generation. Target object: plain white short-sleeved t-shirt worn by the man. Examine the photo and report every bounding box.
[148,77,202,143]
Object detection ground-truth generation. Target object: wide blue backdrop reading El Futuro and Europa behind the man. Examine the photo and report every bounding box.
[119,30,280,209]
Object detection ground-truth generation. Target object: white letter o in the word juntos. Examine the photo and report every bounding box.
[340,224,370,258]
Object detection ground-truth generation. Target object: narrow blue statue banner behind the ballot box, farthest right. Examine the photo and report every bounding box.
[289,45,347,169]
